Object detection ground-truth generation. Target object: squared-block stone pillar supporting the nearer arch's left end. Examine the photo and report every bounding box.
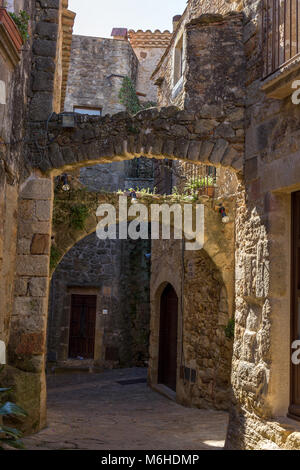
[5,176,53,433]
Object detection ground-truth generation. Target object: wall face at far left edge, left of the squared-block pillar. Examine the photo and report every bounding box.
[0,1,34,343]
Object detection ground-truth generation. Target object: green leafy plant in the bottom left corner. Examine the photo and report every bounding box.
[0,367,27,449]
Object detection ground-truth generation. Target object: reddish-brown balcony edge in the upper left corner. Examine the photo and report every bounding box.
[0,7,23,67]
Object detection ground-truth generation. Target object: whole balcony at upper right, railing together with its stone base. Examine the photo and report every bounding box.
[262,0,300,99]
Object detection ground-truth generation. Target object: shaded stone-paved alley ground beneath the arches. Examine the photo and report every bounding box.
[24,368,228,450]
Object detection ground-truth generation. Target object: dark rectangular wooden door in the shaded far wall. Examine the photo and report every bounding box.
[69,295,97,359]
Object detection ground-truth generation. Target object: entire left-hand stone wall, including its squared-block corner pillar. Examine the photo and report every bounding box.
[0,0,74,431]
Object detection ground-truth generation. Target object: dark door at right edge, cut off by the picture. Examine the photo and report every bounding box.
[289,191,300,420]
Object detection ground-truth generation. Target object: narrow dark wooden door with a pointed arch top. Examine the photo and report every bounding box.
[158,284,178,392]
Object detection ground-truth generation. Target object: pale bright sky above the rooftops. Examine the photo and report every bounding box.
[69,0,187,38]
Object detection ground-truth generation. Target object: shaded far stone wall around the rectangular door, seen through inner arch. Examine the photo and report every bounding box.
[48,229,150,368]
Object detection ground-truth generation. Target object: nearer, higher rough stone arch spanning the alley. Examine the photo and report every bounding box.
[29,106,244,175]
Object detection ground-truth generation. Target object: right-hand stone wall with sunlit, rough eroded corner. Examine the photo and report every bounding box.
[227,1,300,449]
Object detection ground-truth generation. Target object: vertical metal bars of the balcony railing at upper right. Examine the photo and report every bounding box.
[262,0,300,78]
